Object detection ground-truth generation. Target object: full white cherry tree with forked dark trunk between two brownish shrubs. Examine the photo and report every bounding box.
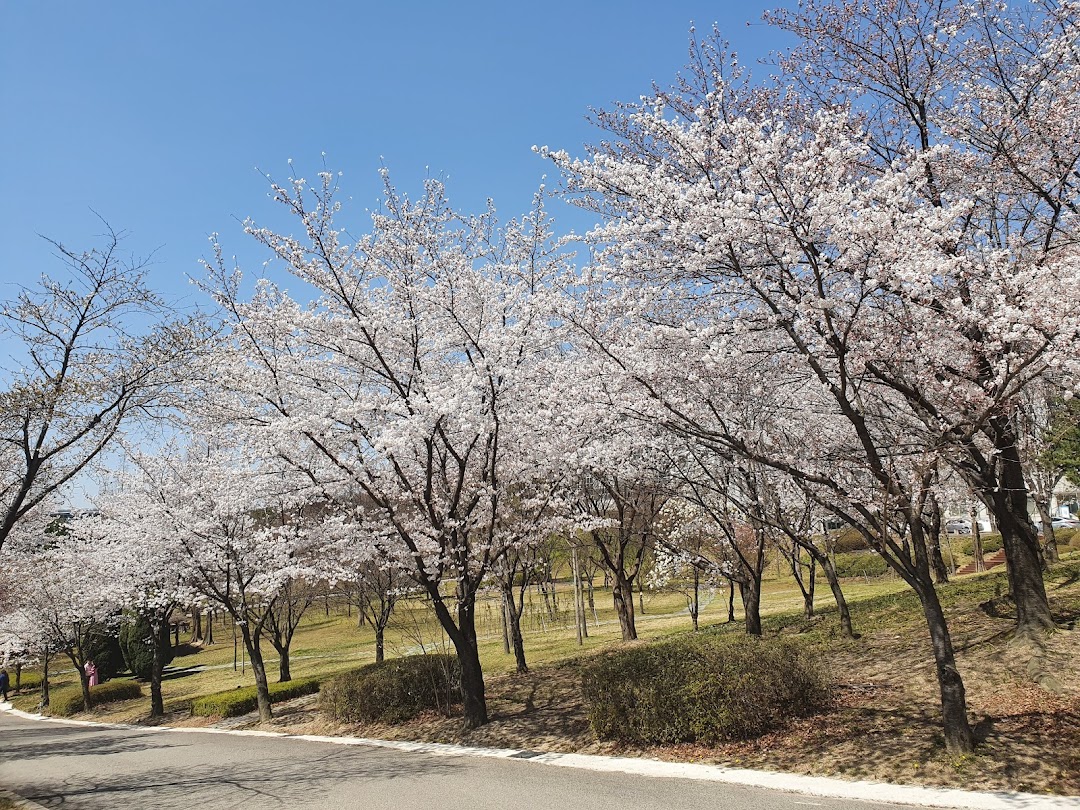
[204,173,567,727]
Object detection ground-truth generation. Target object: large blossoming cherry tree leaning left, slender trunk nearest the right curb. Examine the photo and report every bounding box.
[548,33,1028,751]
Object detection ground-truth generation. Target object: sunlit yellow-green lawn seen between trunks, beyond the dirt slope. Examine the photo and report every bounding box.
[14,563,999,721]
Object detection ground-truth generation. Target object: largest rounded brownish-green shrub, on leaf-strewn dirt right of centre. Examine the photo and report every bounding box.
[582,635,829,743]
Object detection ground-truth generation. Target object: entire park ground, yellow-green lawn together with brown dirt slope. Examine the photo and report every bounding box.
[15,552,1080,794]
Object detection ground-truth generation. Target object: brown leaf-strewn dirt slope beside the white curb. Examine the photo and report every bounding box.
[248,575,1080,794]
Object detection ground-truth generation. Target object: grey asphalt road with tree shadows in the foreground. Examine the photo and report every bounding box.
[0,714,928,810]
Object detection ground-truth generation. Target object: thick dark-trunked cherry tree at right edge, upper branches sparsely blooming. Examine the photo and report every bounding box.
[771,0,1080,640]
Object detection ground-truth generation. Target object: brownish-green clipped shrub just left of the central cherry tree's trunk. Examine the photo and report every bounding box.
[319,654,461,723]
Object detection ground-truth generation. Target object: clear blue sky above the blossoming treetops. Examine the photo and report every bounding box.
[0,0,785,298]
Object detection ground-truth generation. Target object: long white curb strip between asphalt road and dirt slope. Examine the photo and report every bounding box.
[0,704,1080,810]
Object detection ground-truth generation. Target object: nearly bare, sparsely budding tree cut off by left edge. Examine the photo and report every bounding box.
[0,229,204,546]
